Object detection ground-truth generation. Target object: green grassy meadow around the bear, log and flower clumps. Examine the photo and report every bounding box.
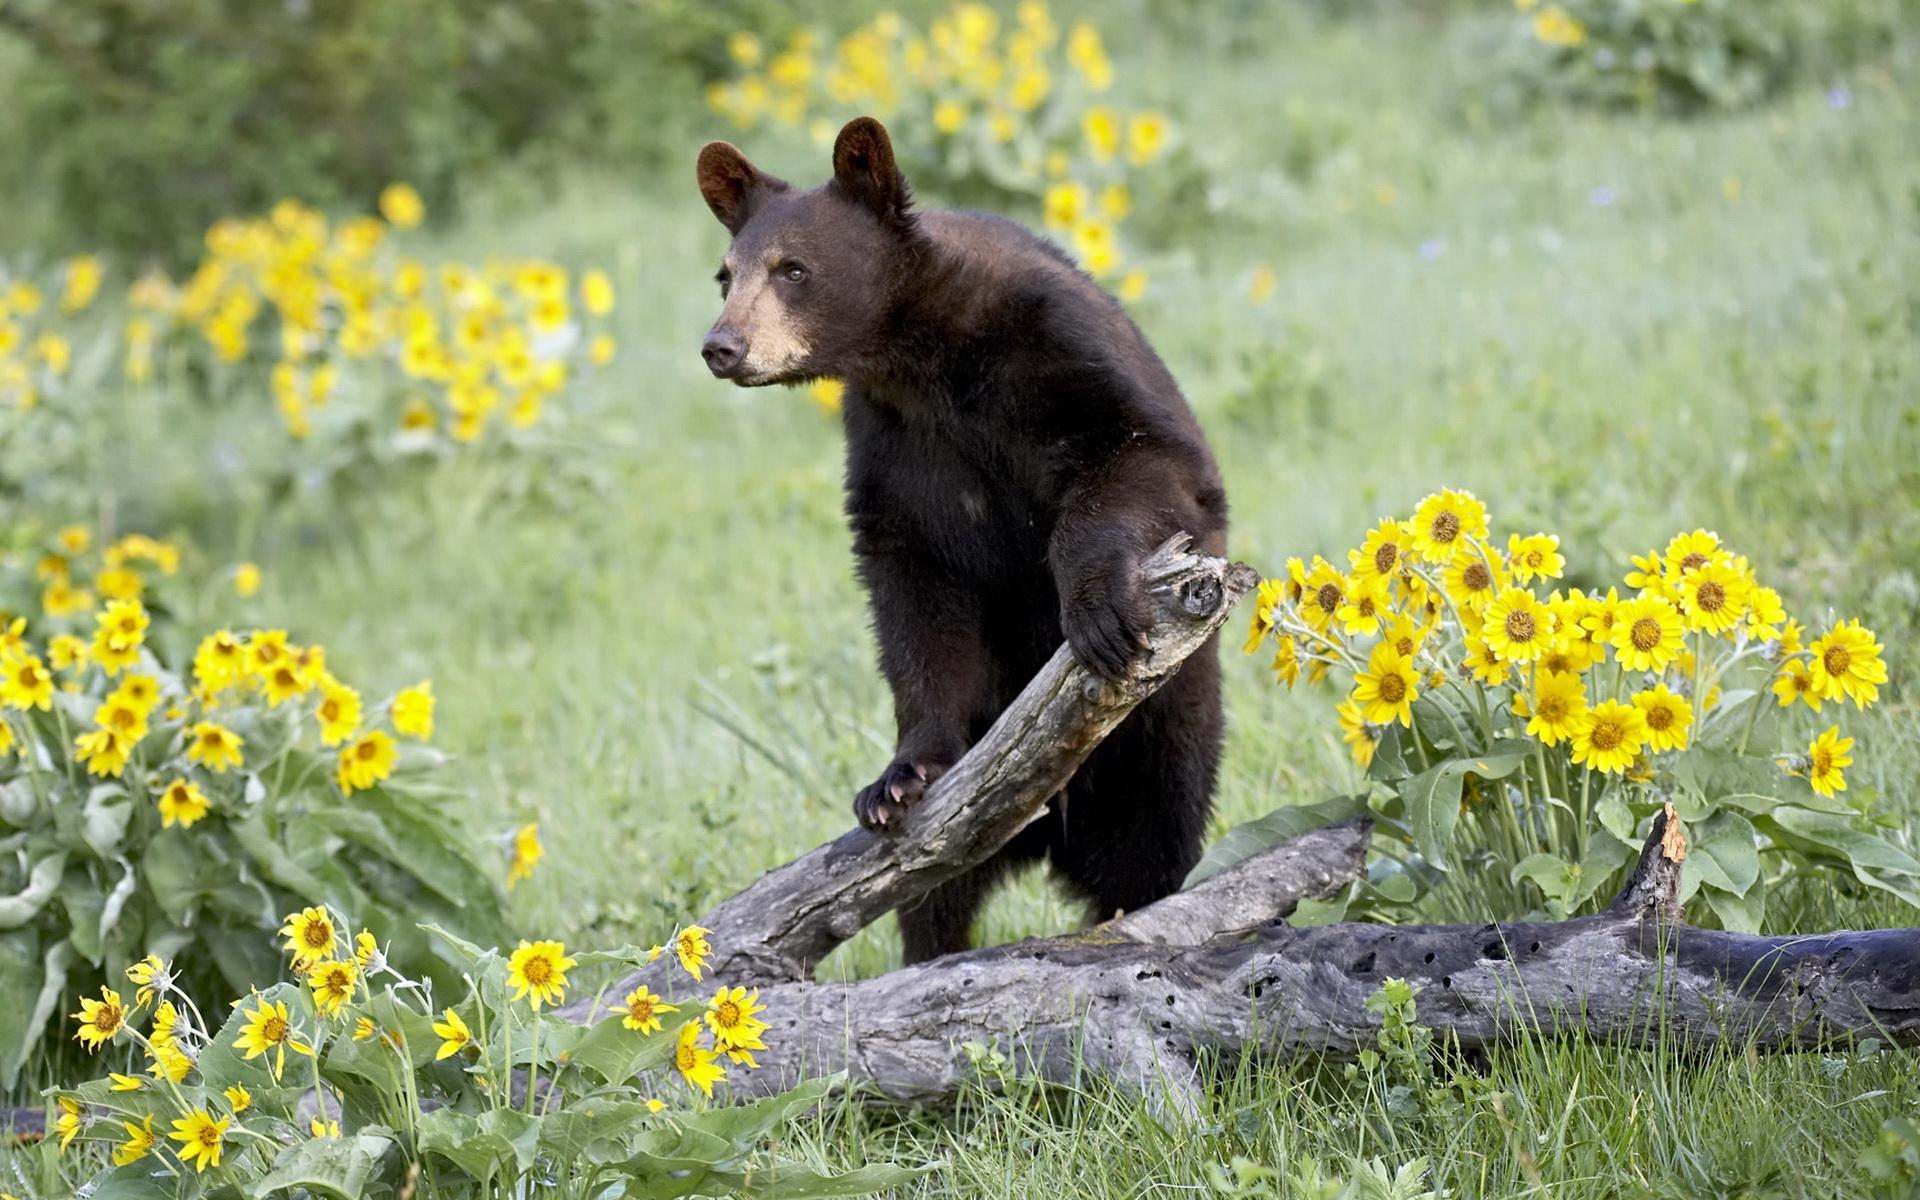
[0,10,1920,1198]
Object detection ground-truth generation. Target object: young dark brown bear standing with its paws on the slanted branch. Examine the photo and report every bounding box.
[699,117,1227,962]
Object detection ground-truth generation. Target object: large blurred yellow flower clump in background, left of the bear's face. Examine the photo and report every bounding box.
[127,184,616,442]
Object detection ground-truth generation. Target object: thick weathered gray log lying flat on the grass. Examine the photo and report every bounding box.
[732,810,1920,1108]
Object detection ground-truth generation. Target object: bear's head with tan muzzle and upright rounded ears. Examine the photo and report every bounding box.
[699,117,920,388]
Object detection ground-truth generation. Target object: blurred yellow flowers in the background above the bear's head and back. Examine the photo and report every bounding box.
[707,0,1175,300]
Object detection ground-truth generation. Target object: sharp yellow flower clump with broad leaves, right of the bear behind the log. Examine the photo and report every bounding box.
[1244,490,1920,927]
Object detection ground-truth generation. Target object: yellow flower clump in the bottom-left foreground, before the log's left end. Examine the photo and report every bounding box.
[50,904,833,1196]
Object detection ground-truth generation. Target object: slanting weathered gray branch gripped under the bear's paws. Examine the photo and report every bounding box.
[566,536,1260,1020]
